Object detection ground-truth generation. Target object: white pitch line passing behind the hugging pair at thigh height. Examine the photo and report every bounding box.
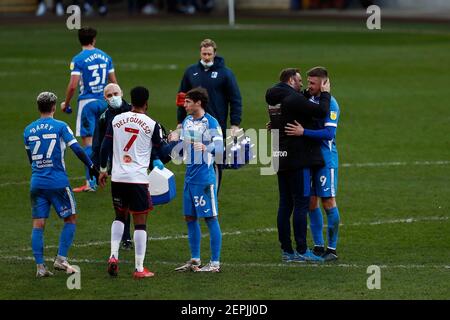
[0,160,450,187]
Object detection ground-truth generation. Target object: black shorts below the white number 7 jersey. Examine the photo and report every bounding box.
[111,181,153,214]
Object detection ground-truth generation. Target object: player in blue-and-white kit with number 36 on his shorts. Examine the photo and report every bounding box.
[171,88,223,272]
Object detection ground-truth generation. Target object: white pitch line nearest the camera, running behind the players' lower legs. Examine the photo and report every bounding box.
[0,217,449,253]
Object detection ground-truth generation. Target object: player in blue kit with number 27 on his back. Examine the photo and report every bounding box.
[24,92,97,278]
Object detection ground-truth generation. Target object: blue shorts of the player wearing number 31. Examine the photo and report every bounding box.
[77,99,105,137]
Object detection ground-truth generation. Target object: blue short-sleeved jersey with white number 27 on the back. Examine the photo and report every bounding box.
[23,118,77,189]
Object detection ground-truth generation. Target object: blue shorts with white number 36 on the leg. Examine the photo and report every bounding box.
[183,183,218,218]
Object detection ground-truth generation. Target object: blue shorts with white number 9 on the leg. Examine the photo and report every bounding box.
[311,167,338,198]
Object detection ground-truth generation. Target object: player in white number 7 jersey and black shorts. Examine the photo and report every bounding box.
[99,87,164,278]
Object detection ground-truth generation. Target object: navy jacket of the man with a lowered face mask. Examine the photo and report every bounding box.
[177,56,242,135]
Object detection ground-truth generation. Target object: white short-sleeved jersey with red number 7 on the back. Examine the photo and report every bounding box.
[105,111,161,184]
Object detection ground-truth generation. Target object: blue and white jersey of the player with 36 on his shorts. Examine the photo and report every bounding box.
[180,113,223,185]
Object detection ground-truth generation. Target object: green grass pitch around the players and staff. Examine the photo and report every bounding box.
[0,20,450,299]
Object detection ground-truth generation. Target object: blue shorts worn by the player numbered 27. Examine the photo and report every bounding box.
[30,187,76,219]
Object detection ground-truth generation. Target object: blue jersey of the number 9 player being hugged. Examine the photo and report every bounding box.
[310,96,339,168]
